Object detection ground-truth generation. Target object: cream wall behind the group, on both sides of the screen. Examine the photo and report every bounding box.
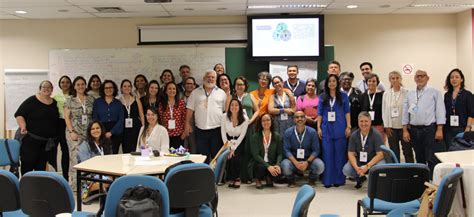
[0,13,472,136]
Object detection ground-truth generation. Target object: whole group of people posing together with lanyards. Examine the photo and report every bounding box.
[15,61,474,189]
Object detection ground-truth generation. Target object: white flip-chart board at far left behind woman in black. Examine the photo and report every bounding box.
[4,69,48,130]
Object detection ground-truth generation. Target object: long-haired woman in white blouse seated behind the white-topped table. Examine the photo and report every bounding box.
[137,108,170,156]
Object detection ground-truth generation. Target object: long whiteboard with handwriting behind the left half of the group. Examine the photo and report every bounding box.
[49,46,225,88]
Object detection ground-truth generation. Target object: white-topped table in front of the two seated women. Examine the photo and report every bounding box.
[74,154,206,211]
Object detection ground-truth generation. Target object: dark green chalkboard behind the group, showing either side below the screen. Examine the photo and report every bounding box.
[225,46,334,90]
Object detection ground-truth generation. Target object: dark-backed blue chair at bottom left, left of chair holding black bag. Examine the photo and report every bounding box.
[20,171,95,217]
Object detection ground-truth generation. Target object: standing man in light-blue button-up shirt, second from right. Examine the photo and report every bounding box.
[402,70,446,167]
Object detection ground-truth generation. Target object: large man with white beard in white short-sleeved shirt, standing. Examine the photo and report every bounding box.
[183,70,227,162]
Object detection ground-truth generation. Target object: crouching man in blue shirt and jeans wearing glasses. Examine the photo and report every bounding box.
[281,111,324,188]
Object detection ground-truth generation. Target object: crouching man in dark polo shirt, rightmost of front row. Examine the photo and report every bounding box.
[342,112,385,189]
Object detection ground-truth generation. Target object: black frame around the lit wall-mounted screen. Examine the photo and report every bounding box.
[247,14,324,61]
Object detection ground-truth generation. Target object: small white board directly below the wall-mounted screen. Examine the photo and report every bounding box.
[270,61,318,81]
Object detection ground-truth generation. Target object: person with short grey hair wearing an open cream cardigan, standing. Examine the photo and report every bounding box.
[382,71,413,163]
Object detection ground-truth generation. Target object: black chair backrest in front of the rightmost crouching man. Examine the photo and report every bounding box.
[367,163,430,209]
